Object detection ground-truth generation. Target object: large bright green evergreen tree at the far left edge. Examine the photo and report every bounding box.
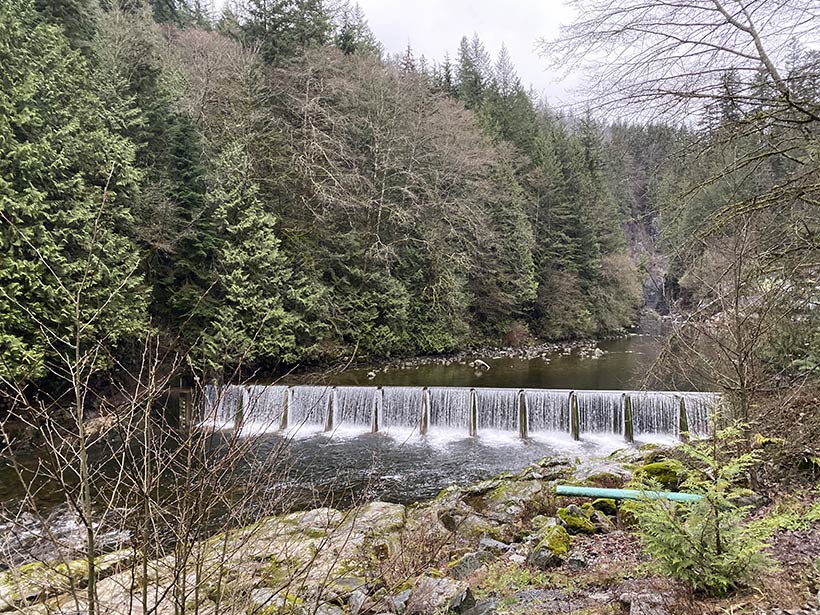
[0,0,146,379]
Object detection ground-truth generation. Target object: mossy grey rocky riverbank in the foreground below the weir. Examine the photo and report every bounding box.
[0,449,820,615]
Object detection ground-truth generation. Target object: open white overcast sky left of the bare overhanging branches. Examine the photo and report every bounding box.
[358,0,572,105]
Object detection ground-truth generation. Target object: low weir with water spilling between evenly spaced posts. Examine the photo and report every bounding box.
[200,385,720,442]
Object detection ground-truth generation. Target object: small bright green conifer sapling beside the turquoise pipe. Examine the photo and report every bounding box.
[624,428,772,596]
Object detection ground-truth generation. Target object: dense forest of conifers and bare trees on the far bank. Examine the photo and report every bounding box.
[0,0,695,382]
